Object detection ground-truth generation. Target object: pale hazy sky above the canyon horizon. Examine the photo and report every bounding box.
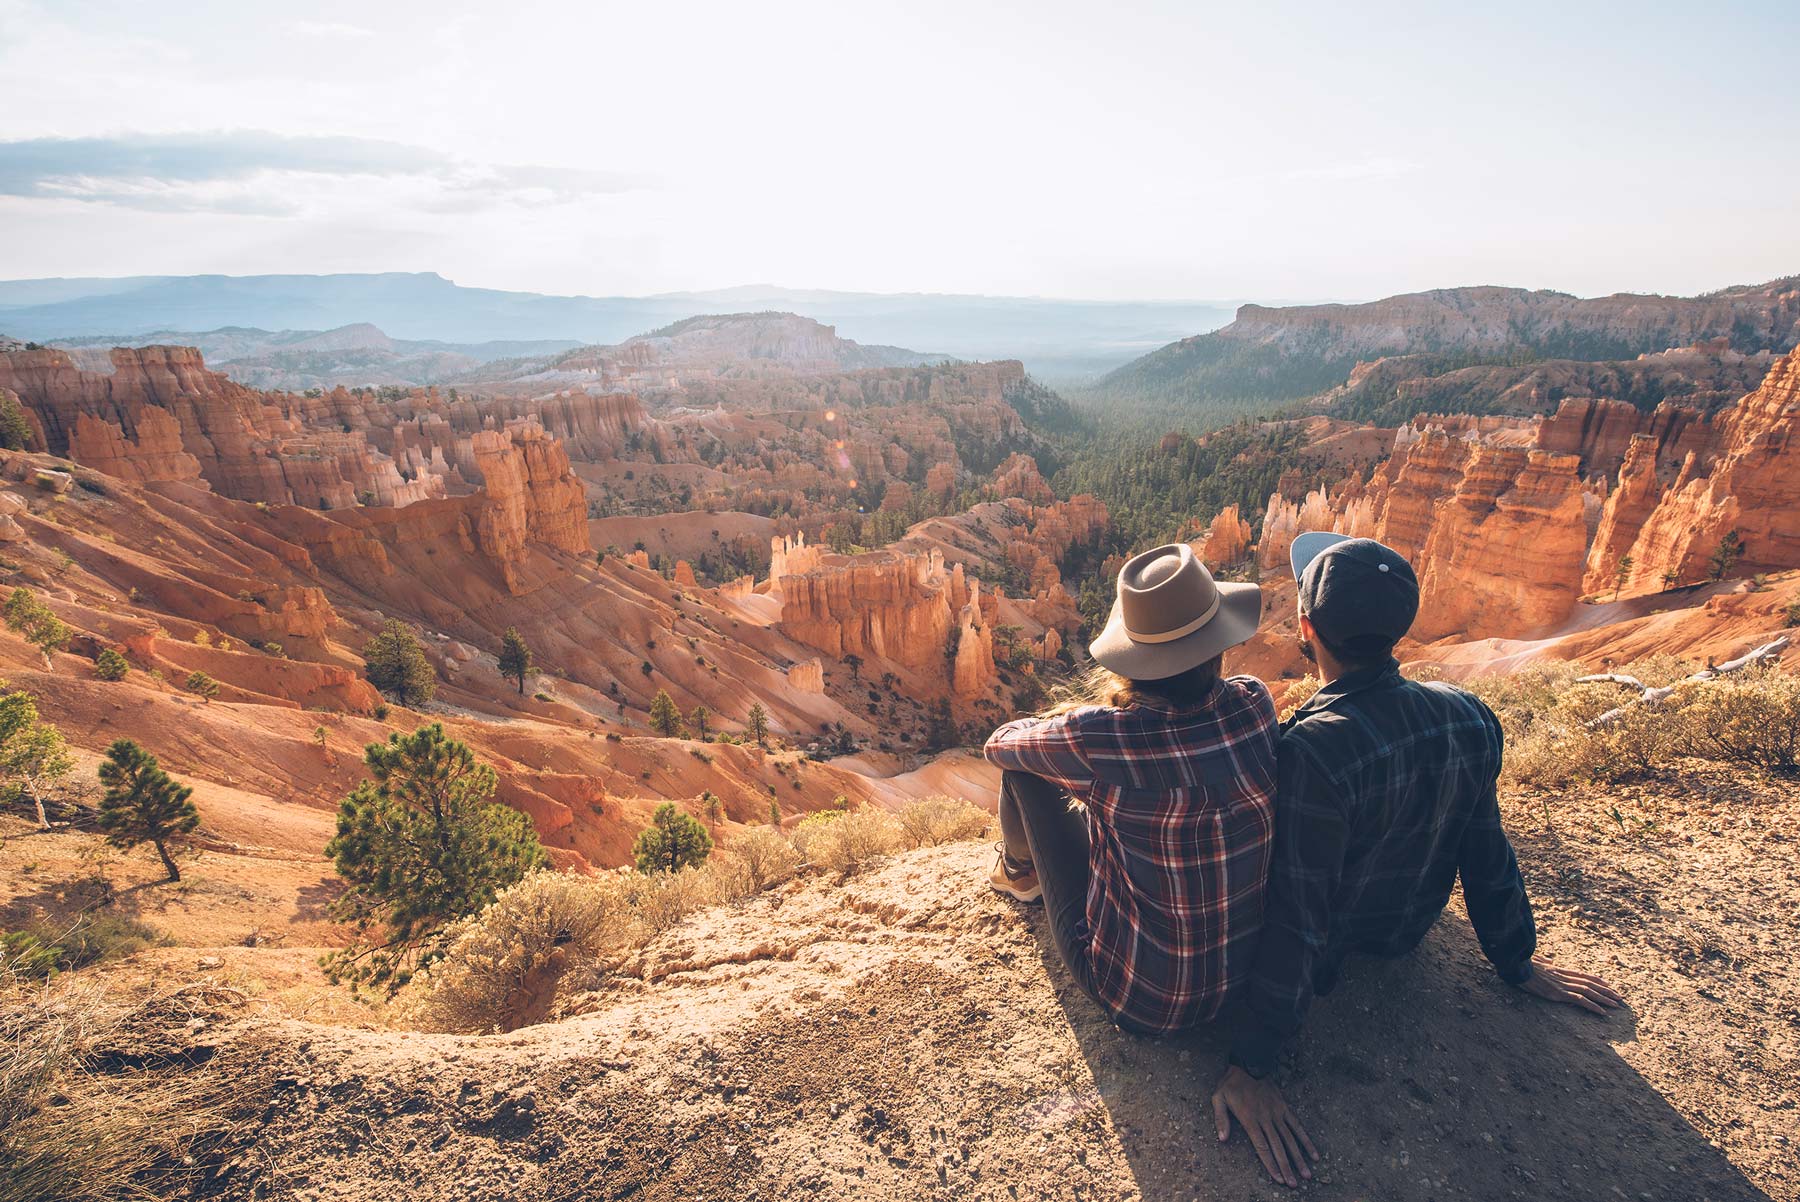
[0,0,1800,299]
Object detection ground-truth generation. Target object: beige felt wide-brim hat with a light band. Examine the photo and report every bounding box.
[1087,543,1262,680]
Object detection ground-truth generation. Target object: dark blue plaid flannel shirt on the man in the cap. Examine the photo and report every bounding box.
[1231,660,1537,1076]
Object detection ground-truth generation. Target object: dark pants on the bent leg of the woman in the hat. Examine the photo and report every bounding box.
[1001,772,1112,1015]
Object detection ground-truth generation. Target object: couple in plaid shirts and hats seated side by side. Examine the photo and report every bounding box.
[986,533,1620,1186]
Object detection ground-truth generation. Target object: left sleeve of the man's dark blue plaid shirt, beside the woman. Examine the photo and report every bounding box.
[1231,736,1350,1076]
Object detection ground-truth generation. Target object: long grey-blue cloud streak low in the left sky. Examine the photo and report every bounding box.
[0,130,646,216]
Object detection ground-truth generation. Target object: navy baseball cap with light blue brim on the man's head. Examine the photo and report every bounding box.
[1289,531,1418,657]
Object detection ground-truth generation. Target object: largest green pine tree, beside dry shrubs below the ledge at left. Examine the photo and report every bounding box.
[326,723,545,991]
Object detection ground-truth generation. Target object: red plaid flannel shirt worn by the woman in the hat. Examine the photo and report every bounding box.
[986,677,1278,1033]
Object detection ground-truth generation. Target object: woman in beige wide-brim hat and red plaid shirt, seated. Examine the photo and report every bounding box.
[986,543,1278,1035]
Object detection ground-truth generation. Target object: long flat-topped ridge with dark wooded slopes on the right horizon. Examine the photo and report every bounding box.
[1096,277,1800,421]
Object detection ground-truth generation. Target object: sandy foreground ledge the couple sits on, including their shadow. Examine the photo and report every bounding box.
[10,765,1800,1202]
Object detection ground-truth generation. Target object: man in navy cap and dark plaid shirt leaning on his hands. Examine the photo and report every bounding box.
[1213,533,1622,1186]
